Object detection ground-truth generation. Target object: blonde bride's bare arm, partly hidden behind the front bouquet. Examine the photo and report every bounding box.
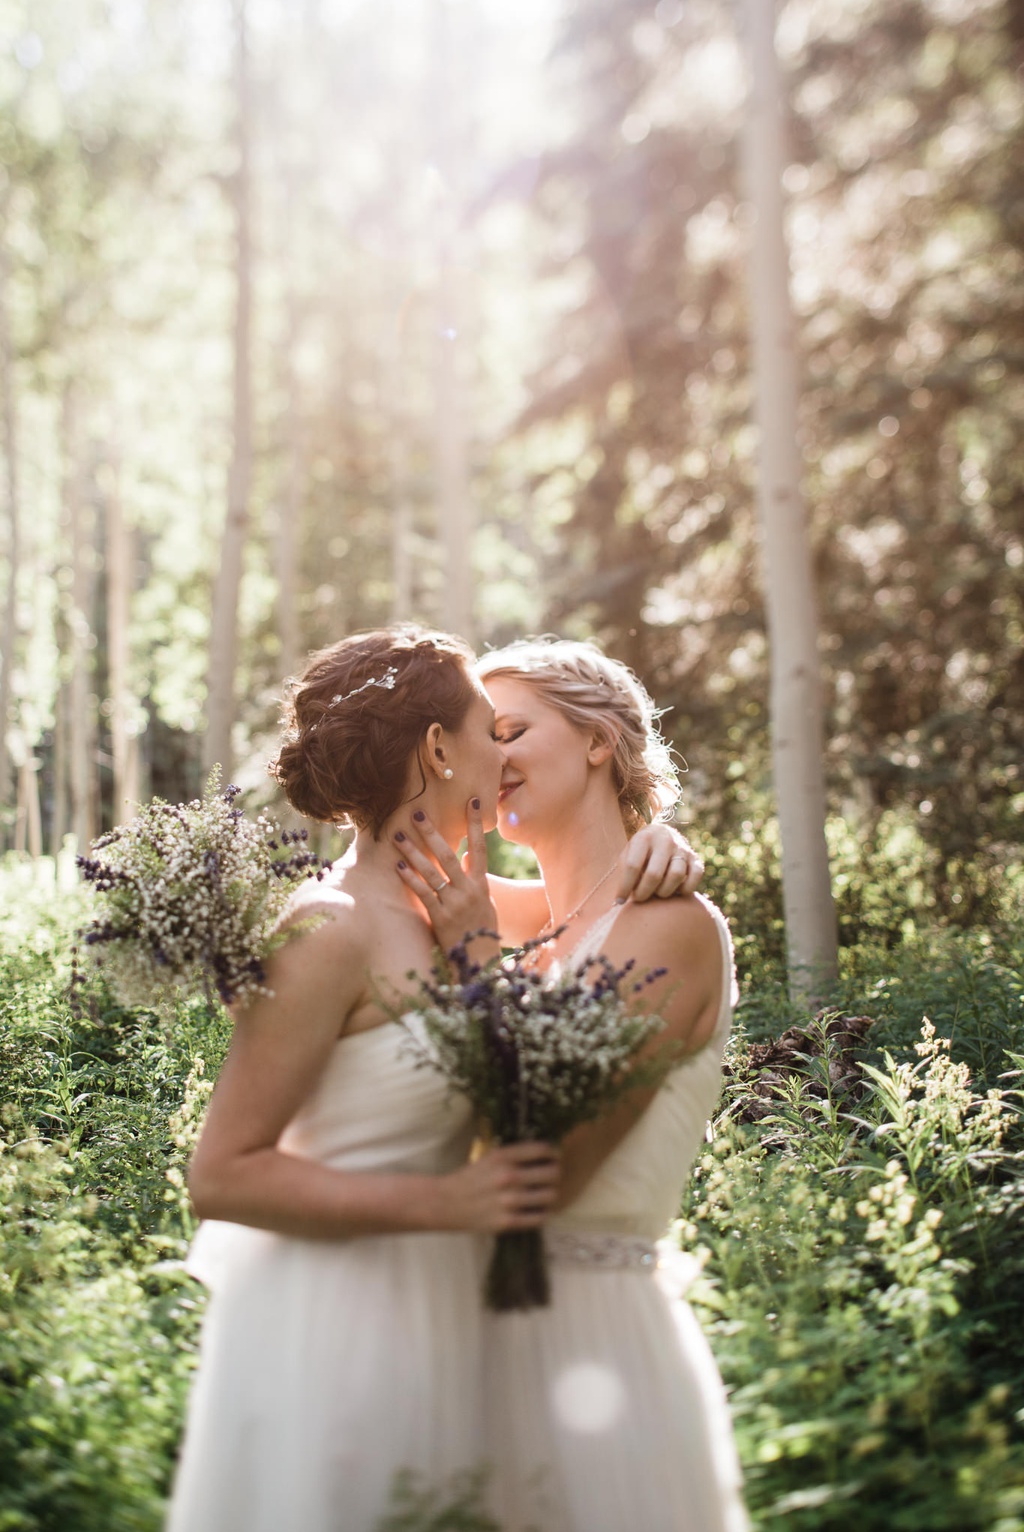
[556,899,722,1207]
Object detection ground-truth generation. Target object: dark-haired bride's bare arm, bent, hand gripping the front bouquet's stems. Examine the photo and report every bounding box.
[189,899,558,1239]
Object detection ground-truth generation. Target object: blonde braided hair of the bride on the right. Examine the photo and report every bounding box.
[477,637,679,835]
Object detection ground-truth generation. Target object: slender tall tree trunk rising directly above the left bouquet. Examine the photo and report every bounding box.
[204,0,253,778]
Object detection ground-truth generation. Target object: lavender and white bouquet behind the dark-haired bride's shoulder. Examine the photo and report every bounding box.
[78,768,331,1010]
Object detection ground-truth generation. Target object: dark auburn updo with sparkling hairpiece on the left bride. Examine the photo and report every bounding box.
[268,624,477,840]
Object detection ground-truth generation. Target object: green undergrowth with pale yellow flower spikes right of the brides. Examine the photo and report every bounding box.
[684,1023,1024,1532]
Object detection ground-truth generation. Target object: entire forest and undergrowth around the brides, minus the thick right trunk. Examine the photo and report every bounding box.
[0,0,1024,1532]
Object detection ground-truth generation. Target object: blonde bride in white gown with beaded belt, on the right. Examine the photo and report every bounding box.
[398,640,748,1532]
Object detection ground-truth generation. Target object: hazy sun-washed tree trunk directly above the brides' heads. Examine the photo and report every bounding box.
[432,0,474,643]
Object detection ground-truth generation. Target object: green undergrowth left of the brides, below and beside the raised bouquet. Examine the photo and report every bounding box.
[0,863,227,1532]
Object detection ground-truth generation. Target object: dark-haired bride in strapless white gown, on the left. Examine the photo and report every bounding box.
[167,628,699,1532]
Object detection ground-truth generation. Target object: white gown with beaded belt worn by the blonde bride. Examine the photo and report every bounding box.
[484,901,748,1532]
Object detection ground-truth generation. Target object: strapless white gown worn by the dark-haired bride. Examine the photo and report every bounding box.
[167,1023,483,1532]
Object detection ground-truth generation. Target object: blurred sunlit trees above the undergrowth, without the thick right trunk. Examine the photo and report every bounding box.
[0,0,1024,922]
